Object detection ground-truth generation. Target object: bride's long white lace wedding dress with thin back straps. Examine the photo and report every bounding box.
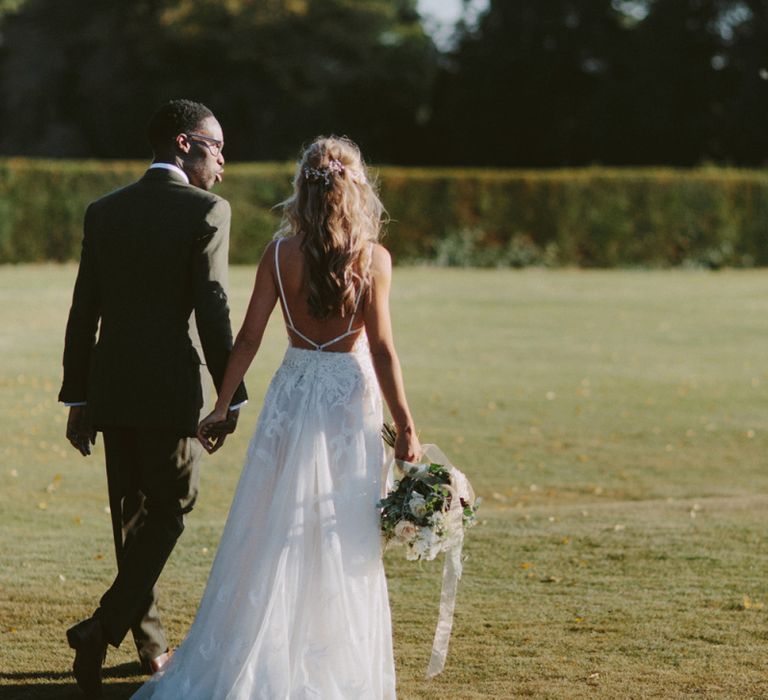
[133,241,395,700]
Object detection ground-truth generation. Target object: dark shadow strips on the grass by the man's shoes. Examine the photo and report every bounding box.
[0,662,143,700]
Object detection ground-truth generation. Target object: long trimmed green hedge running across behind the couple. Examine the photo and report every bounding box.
[0,158,768,267]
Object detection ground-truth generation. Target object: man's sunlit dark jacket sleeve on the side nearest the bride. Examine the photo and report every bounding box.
[194,199,248,404]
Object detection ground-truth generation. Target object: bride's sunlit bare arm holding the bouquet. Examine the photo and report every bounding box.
[364,245,421,462]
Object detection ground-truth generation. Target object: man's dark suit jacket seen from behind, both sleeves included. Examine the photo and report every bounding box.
[59,169,247,436]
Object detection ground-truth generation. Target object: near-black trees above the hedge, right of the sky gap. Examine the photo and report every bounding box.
[432,0,768,166]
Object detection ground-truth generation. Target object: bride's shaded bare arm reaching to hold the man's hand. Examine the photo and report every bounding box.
[197,242,277,449]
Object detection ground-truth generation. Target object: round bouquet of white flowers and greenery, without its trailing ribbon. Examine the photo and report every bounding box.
[378,423,479,561]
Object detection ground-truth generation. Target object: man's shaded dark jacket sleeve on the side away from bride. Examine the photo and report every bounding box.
[59,206,101,403]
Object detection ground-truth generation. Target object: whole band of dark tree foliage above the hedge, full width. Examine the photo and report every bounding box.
[0,0,768,166]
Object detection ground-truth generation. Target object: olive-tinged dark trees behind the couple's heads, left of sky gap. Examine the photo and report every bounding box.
[0,0,436,160]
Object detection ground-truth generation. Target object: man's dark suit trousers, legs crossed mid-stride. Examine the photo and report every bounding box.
[95,427,202,662]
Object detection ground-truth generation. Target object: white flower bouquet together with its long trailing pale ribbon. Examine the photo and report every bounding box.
[378,423,480,678]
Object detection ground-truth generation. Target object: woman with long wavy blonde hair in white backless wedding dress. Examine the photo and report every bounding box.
[133,138,421,700]
